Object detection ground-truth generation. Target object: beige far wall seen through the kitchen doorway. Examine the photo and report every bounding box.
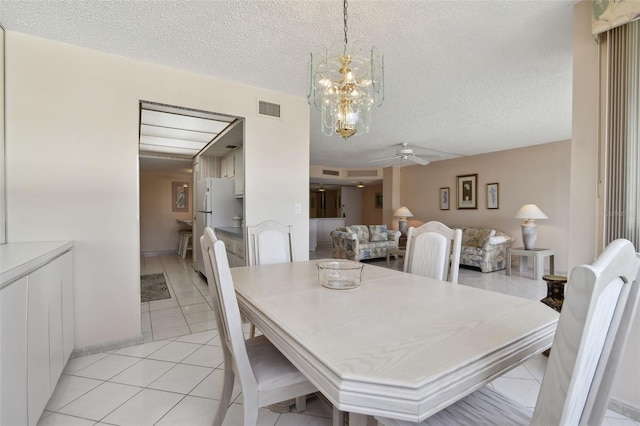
[140,173,193,254]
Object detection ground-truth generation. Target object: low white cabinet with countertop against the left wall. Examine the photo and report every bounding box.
[0,243,75,425]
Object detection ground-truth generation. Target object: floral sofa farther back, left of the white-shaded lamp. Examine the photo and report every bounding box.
[331,225,400,261]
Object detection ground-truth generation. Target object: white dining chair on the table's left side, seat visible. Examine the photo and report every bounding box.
[200,227,317,426]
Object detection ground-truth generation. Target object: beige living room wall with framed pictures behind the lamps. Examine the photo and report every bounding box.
[400,141,571,273]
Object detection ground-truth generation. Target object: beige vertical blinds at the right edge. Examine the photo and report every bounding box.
[604,21,640,251]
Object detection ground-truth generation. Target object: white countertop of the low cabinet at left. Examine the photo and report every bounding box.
[0,241,73,288]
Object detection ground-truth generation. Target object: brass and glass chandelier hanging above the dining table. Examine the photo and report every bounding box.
[307,0,384,139]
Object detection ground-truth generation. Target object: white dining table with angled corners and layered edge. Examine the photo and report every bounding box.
[231,260,558,426]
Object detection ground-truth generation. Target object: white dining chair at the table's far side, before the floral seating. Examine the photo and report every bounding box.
[404,221,462,284]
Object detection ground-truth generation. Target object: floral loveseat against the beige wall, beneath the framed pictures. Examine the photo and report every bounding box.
[451,226,512,272]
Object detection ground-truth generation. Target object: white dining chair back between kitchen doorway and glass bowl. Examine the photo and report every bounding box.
[247,220,293,265]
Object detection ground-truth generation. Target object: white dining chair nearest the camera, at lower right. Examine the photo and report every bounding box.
[377,239,640,426]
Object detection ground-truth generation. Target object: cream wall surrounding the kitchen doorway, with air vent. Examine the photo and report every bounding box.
[6,32,309,348]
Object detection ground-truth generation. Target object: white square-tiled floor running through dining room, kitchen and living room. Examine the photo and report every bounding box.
[38,249,640,426]
